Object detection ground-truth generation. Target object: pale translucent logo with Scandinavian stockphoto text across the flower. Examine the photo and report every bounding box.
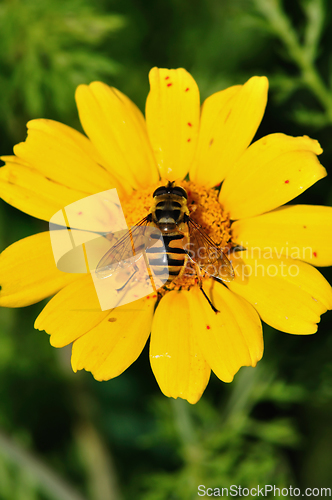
[49,189,314,311]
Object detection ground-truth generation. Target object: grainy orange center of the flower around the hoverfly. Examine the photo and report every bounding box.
[122,181,232,295]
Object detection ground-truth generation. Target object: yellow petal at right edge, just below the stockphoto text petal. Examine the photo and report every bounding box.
[227,250,332,334]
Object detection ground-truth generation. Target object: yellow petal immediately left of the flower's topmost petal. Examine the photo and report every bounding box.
[76,82,158,187]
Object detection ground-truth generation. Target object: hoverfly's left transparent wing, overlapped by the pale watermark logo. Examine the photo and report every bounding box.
[96,216,152,278]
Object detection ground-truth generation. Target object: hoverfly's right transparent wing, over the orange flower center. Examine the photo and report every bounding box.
[188,218,235,281]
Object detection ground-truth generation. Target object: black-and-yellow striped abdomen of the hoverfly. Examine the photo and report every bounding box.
[146,232,187,285]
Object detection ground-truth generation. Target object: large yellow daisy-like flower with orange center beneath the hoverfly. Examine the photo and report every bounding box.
[0,68,332,403]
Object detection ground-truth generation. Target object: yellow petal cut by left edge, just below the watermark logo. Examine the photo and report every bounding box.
[0,232,78,307]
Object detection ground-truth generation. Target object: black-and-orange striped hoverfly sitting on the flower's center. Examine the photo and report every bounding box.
[96,182,234,312]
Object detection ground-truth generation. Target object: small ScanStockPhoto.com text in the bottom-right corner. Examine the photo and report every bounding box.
[197,484,331,498]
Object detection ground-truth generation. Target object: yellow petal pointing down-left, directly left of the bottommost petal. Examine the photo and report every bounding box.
[72,297,155,380]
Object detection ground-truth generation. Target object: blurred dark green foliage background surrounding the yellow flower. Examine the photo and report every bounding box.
[0,0,332,500]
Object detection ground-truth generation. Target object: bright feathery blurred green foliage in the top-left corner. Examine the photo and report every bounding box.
[0,0,124,142]
